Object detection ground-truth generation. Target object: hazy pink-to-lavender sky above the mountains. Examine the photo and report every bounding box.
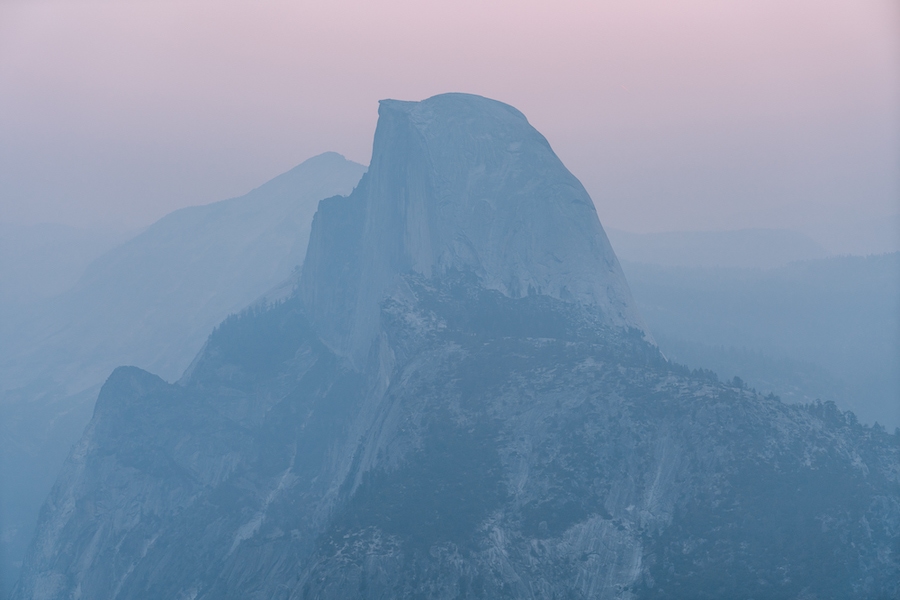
[0,0,900,250]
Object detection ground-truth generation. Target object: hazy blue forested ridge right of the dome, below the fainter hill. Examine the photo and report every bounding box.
[622,252,900,429]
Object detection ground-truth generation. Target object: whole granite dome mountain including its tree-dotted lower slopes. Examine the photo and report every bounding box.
[16,95,900,600]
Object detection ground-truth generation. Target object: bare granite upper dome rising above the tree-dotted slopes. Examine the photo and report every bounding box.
[301,94,643,364]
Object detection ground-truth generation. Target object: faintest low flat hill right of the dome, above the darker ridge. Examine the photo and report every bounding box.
[607,229,828,269]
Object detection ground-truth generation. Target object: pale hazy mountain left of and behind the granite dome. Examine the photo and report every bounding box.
[0,153,365,593]
